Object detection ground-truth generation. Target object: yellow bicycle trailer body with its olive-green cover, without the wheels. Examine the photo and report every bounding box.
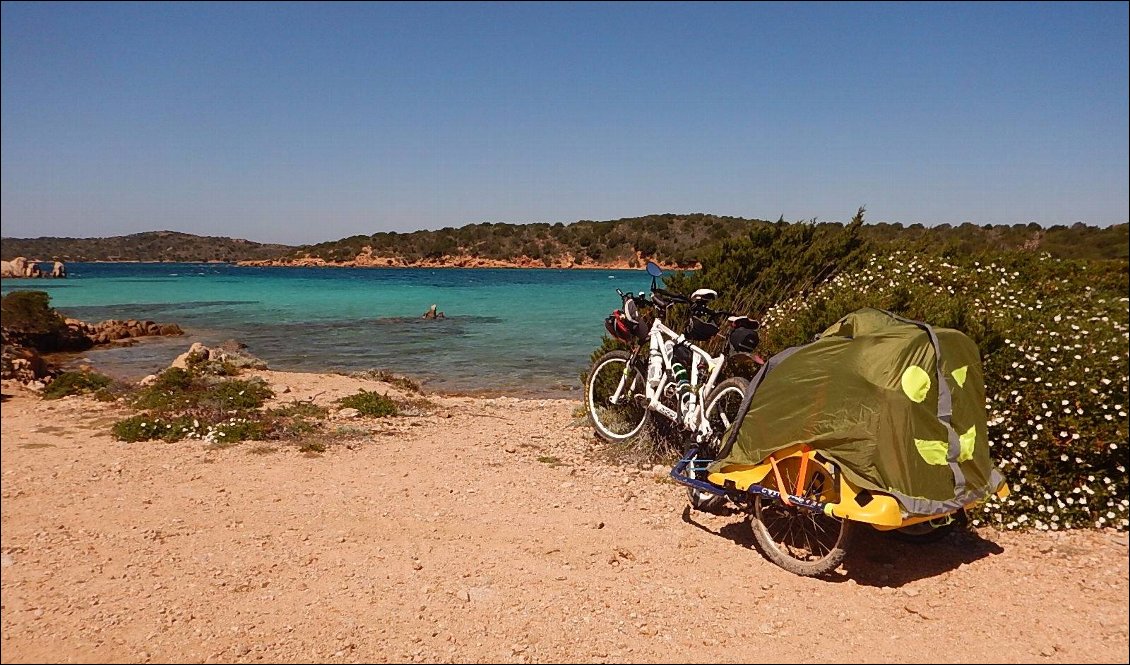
[671,308,1008,574]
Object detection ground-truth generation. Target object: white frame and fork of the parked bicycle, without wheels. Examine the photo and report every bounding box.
[610,317,725,442]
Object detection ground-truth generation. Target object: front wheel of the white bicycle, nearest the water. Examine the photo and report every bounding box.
[584,351,651,443]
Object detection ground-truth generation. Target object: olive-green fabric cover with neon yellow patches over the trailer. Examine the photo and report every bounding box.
[711,308,1005,517]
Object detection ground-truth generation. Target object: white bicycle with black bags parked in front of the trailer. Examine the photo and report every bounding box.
[585,261,759,509]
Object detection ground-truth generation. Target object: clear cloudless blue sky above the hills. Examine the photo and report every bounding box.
[0,2,1130,243]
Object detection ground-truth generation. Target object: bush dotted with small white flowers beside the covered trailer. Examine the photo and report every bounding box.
[762,252,1130,530]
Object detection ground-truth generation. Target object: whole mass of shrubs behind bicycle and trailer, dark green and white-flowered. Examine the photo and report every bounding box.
[594,209,1130,530]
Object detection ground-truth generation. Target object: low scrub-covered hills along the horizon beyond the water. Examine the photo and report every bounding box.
[0,214,1130,269]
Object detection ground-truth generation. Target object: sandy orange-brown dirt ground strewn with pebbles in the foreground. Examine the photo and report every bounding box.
[0,375,1128,663]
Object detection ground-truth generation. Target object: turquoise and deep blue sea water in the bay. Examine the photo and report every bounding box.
[0,264,651,396]
